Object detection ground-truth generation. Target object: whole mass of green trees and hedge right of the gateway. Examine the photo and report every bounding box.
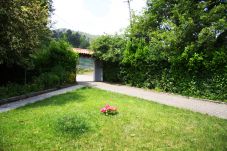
[93,0,227,100]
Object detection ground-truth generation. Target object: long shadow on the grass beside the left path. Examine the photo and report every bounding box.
[18,88,90,110]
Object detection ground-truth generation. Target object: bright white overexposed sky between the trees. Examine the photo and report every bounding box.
[52,0,146,35]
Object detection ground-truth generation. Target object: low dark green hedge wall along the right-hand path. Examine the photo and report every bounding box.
[103,61,227,101]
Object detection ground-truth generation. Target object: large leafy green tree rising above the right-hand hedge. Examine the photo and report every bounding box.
[128,0,227,73]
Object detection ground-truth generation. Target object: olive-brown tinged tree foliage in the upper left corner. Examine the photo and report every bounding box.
[0,0,52,69]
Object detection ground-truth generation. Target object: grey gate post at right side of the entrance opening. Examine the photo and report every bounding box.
[94,60,103,82]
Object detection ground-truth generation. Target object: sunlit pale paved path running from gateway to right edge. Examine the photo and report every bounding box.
[79,82,227,119]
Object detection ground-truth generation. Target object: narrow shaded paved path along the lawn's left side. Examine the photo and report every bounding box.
[0,85,84,113]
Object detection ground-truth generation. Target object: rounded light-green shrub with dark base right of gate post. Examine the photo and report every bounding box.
[91,35,127,82]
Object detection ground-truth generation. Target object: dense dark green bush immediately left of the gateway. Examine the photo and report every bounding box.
[33,40,78,88]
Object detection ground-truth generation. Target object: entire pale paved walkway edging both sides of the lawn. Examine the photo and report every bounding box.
[0,82,227,119]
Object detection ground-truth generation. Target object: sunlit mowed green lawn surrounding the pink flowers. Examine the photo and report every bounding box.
[0,88,227,151]
